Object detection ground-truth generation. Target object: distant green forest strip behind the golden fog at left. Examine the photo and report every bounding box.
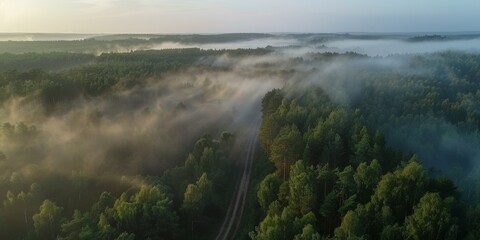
[0,47,270,105]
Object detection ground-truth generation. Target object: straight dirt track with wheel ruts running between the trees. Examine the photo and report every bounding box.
[215,119,260,240]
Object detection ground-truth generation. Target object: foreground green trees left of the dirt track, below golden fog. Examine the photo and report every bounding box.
[0,129,235,240]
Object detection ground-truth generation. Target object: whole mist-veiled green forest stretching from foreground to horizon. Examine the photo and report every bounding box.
[0,34,480,240]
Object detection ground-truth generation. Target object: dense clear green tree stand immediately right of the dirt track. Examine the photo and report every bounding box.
[250,86,470,239]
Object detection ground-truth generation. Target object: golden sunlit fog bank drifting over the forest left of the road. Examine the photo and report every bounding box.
[1,54,284,176]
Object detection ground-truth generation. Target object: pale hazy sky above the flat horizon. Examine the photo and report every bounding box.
[0,0,480,33]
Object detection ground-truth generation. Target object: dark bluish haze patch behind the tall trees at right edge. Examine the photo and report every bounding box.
[387,117,480,174]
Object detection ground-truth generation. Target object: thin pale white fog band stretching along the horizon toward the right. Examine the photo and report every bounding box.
[146,35,480,57]
